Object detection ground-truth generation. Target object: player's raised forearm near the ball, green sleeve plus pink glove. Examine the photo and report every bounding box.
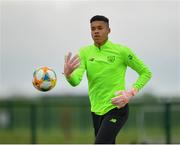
[64,49,85,86]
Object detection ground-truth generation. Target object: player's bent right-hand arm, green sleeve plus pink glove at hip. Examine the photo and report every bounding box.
[112,47,152,108]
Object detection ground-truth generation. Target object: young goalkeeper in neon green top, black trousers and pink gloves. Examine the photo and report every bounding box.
[64,15,151,144]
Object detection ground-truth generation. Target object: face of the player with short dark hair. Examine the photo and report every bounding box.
[91,21,110,46]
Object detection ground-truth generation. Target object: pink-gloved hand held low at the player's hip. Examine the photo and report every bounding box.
[112,88,138,108]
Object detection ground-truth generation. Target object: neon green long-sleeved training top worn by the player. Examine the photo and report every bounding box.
[67,40,151,115]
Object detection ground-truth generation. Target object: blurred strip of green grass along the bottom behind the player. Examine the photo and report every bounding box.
[0,128,180,144]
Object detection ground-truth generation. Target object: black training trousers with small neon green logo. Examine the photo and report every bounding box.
[92,104,129,144]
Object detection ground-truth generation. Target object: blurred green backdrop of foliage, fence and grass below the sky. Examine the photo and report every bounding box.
[0,94,180,144]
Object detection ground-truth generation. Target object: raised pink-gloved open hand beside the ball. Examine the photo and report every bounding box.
[64,52,80,78]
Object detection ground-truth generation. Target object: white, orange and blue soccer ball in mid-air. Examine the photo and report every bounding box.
[32,67,57,92]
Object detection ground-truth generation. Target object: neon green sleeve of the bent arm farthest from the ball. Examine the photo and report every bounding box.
[125,47,152,90]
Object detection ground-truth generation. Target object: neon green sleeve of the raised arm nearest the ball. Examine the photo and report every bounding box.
[66,49,86,86]
